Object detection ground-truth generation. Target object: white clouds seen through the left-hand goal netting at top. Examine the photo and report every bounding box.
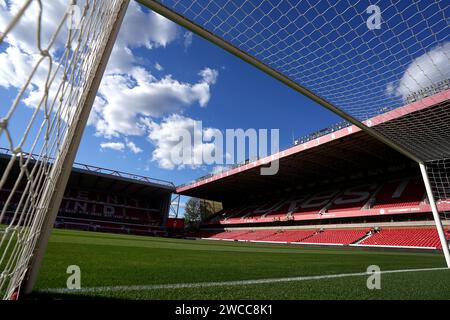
[0,0,71,112]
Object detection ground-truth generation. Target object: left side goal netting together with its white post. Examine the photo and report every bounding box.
[0,0,128,299]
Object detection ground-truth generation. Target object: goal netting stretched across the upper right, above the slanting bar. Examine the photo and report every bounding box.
[139,0,450,258]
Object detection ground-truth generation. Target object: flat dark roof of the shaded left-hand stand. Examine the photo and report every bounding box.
[0,148,175,197]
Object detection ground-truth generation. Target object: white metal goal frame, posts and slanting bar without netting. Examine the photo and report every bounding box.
[0,0,450,300]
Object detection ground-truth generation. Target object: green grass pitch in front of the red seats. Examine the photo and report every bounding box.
[31,230,450,299]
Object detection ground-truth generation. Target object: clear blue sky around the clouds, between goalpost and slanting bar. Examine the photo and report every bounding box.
[5,0,339,185]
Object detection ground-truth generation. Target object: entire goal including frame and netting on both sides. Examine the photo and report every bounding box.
[0,0,450,299]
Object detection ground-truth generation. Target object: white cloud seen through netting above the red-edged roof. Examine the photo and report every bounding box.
[386,42,450,99]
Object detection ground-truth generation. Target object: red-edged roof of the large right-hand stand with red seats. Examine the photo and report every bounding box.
[177,90,450,201]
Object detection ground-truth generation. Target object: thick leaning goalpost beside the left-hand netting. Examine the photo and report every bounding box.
[20,0,130,294]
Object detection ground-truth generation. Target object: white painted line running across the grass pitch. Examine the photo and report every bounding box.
[41,267,450,294]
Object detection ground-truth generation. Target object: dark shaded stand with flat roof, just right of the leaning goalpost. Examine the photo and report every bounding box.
[0,149,175,235]
